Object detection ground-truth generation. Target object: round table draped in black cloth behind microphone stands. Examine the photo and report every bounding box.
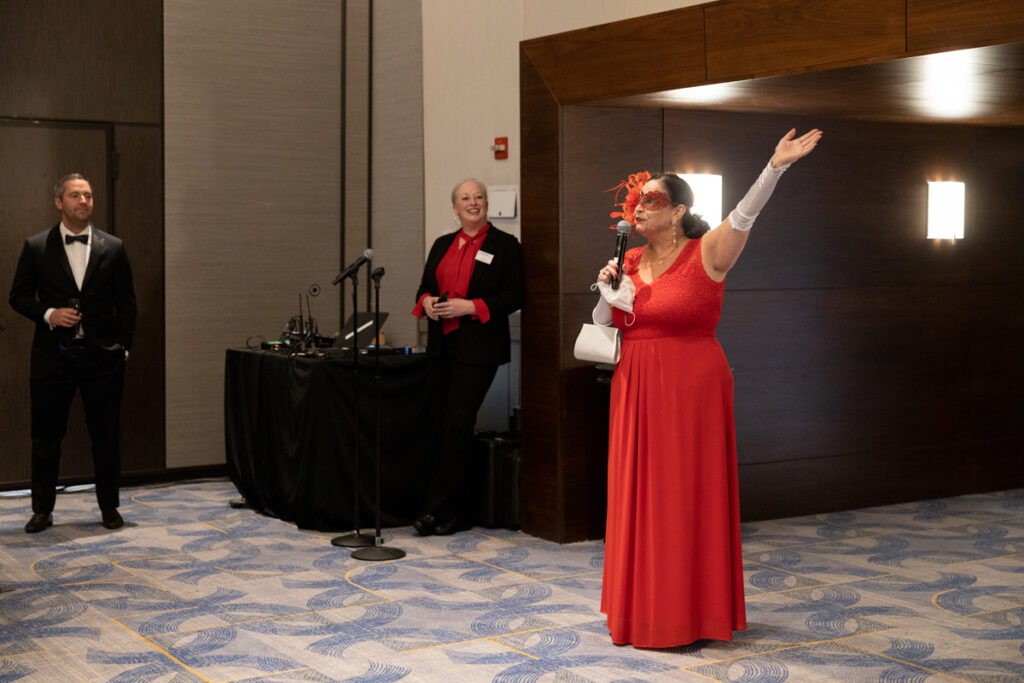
[224,349,432,532]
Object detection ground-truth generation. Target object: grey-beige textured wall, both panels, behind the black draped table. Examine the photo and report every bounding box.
[164,0,423,468]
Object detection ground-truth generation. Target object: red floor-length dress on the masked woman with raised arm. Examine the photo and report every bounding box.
[601,240,746,647]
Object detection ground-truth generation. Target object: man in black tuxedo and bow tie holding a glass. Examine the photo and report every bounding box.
[9,173,136,533]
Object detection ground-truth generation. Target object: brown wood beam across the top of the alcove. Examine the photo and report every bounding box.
[520,0,1024,104]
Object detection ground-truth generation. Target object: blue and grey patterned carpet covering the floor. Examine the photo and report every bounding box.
[0,480,1024,683]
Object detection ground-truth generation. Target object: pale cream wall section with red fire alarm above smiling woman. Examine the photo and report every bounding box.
[422,0,700,249]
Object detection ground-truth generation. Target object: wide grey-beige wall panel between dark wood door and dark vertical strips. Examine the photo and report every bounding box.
[164,0,342,468]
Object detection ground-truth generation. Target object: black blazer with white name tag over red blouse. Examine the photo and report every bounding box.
[416,225,526,366]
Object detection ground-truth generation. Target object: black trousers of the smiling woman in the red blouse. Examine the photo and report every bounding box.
[425,331,498,522]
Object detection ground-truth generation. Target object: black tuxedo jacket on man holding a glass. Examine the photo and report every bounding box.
[9,223,136,375]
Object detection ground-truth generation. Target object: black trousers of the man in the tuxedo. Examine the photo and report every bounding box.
[30,361,125,514]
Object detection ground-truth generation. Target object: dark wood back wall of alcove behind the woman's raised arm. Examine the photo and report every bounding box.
[665,111,1024,518]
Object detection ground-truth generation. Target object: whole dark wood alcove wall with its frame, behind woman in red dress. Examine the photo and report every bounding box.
[520,0,1024,541]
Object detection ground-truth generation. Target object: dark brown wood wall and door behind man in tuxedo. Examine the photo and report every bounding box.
[0,0,165,487]
